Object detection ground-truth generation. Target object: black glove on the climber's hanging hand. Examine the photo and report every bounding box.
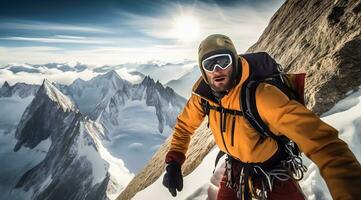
[163,161,183,197]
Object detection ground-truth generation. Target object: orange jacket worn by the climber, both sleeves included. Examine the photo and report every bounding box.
[167,55,361,199]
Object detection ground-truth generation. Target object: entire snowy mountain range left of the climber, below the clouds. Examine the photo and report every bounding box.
[0,63,186,199]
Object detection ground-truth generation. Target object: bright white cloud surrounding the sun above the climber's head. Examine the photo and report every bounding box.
[115,0,282,53]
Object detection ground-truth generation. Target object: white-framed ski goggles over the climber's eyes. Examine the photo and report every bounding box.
[202,54,232,72]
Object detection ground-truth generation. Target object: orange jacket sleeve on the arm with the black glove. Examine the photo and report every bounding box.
[166,94,204,164]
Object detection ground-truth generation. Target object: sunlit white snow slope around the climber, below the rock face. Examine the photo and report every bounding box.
[133,87,361,200]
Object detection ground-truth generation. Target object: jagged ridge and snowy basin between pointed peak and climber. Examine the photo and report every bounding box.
[95,76,186,172]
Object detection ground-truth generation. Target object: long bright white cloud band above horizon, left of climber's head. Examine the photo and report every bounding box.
[0,45,197,66]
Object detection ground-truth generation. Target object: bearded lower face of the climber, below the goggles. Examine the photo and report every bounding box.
[205,64,233,92]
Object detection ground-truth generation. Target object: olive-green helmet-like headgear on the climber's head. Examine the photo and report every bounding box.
[198,34,240,83]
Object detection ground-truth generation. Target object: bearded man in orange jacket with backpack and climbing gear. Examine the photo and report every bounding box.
[163,34,361,200]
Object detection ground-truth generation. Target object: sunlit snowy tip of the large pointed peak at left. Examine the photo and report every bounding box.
[39,79,75,111]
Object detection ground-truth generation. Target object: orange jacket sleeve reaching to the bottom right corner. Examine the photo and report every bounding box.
[256,84,361,199]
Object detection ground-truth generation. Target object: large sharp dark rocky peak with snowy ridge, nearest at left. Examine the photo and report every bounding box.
[14,80,133,199]
